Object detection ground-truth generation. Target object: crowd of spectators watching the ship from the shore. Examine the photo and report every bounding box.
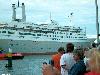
[42,43,100,75]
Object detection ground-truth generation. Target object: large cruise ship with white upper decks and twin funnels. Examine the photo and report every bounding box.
[0,1,94,53]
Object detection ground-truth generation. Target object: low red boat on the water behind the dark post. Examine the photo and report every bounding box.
[0,53,24,60]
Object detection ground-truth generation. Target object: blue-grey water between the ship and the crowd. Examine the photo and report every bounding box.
[0,55,51,75]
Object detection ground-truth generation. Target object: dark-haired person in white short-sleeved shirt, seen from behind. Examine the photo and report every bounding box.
[60,43,75,75]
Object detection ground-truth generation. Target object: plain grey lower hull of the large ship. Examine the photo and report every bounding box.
[0,39,93,53]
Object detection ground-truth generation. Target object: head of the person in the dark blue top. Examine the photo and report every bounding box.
[73,49,84,61]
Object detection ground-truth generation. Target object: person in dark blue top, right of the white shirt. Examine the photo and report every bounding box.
[68,49,86,75]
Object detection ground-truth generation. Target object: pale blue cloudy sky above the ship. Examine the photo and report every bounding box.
[0,0,100,35]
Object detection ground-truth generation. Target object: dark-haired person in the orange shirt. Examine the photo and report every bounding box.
[52,47,64,71]
